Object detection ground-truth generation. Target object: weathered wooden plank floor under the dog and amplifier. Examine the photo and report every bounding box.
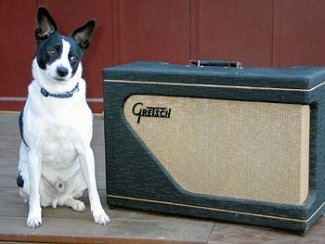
[0,113,325,243]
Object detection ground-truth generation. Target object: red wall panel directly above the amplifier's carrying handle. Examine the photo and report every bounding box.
[192,0,273,66]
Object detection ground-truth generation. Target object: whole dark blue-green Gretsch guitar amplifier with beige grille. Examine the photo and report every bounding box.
[103,62,325,233]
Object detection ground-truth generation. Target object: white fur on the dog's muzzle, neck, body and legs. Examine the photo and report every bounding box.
[19,48,110,228]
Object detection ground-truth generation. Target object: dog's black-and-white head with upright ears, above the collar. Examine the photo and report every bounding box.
[35,7,95,82]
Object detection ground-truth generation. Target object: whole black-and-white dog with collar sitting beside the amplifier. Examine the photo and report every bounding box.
[17,6,110,228]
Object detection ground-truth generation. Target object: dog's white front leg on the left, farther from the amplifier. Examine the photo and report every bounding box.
[27,150,42,229]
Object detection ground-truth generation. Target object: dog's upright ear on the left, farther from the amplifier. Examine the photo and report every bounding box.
[35,6,57,40]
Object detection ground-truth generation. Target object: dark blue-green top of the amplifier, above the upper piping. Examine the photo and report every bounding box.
[103,62,325,90]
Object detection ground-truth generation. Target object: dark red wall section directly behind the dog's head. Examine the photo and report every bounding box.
[0,0,113,112]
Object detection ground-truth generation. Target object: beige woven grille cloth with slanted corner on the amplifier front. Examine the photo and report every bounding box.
[124,95,310,204]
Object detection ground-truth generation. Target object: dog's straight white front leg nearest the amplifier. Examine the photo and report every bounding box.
[80,147,110,225]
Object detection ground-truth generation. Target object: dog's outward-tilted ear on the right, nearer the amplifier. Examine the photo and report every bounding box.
[71,19,96,50]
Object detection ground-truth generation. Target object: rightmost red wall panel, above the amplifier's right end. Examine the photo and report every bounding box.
[274,0,325,67]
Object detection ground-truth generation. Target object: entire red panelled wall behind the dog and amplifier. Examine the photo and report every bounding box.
[0,0,325,112]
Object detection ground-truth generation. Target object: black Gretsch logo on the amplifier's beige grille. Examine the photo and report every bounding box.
[132,103,172,124]
